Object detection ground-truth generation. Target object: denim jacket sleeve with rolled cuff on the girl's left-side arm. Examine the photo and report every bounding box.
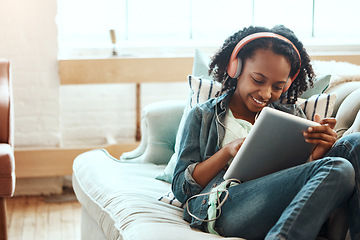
[171,107,203,203]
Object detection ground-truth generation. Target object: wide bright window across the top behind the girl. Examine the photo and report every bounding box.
[57,0,360,55]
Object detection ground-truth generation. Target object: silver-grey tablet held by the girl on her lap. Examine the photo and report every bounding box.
[224,107,320,182]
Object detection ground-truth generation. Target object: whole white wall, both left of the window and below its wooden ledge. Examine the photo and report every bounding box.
[0,0,187,148]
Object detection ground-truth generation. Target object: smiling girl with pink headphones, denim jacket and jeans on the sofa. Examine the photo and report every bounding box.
[172,26,360,239]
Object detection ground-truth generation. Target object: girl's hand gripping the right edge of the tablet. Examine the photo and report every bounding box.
[304,114,337,161]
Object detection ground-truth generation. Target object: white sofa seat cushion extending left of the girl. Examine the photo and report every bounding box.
[73,150,239,240]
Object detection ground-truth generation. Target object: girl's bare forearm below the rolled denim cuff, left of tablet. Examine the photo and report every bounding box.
[192,138,244,187]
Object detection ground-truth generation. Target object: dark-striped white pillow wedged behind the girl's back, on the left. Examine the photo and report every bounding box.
[156,76,221,183]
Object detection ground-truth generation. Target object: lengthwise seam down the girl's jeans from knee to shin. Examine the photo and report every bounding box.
[279,161,334,238]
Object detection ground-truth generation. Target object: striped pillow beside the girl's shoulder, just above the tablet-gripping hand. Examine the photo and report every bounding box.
[297,93,336,121]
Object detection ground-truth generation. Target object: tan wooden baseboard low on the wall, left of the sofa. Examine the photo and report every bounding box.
[15,142,139,178]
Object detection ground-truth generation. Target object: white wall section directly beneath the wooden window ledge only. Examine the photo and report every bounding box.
[60,81,188,147]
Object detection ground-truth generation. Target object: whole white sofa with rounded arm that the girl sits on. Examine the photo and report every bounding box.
[73,58,360,240]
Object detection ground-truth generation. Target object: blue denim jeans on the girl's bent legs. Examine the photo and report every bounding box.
[216,134,360,240]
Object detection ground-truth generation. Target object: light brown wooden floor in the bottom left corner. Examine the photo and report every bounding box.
[6,197,81,240]
